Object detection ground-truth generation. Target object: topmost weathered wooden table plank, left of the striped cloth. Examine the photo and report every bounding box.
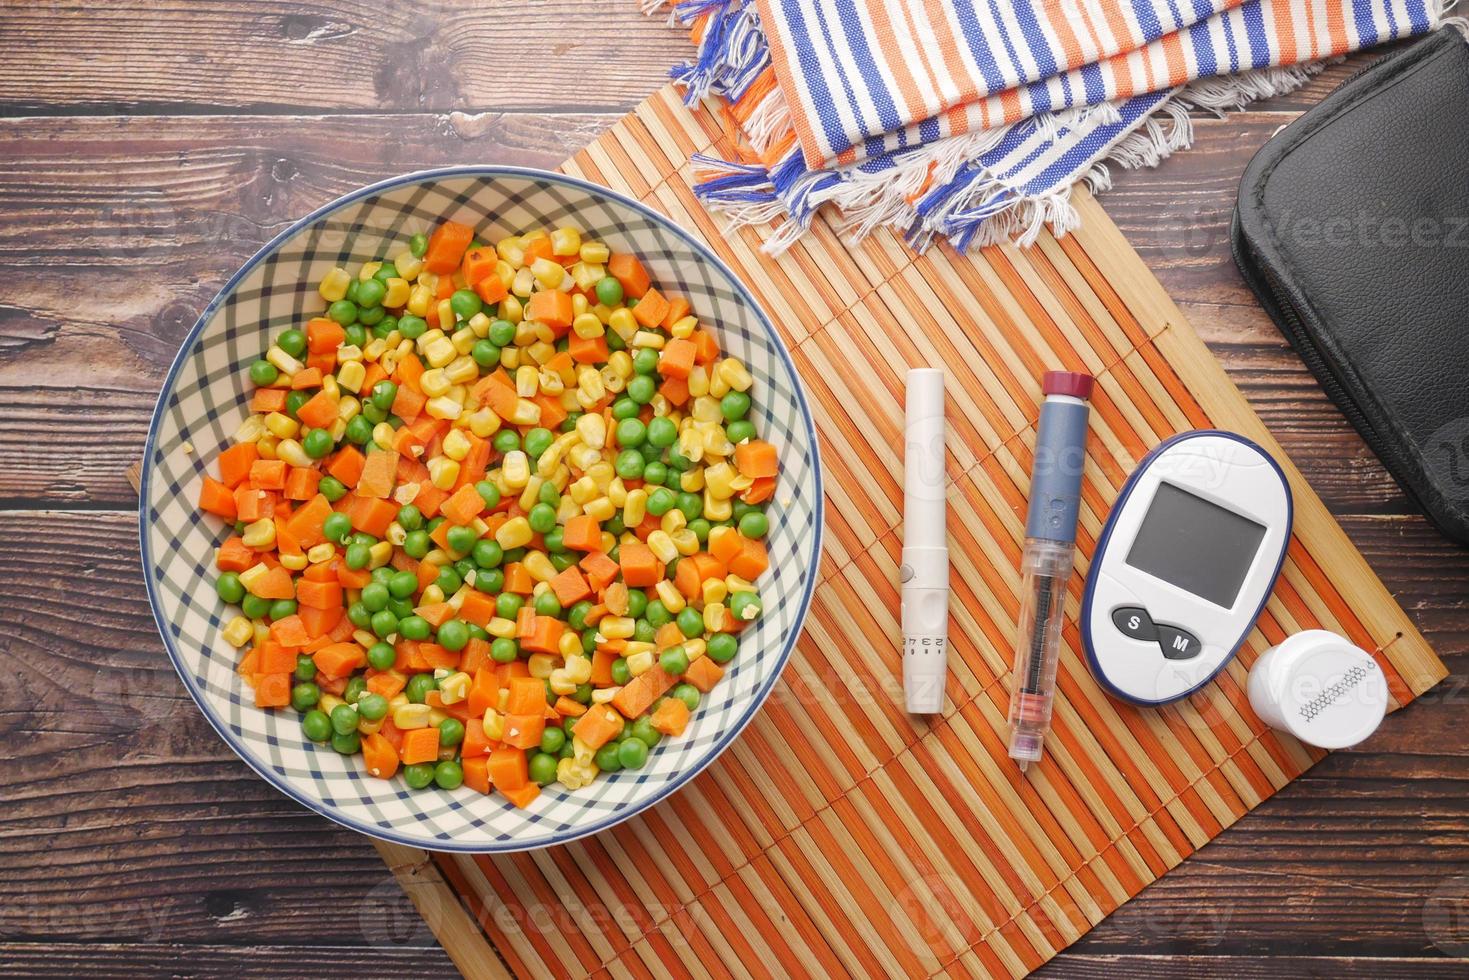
[0,0,690,115]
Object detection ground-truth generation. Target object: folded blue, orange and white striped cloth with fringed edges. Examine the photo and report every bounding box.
[661,0,1451,253]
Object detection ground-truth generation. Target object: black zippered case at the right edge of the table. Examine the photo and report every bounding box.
[1231,28,1469,544]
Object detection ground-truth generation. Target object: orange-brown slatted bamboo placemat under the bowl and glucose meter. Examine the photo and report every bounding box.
[388,87,1445,977]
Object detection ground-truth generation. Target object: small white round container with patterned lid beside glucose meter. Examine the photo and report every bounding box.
[1249,629,1388,749]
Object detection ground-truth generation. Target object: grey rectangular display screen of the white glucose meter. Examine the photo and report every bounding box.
[1127,483,1265,608]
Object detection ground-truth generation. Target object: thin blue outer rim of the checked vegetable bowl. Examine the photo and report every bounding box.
[138,166,826,854]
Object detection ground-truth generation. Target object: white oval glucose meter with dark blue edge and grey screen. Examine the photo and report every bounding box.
[1081,429,1291,705]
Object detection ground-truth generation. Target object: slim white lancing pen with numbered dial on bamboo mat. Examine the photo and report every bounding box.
[899,367,949,714]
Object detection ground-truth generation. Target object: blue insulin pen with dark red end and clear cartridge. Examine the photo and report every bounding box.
[1009,370,1091,771]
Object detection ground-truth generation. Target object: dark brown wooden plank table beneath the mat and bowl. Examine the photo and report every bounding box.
[0,0,1469,977]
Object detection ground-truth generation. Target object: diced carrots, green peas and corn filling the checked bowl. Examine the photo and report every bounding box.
[198,222,777,807]
